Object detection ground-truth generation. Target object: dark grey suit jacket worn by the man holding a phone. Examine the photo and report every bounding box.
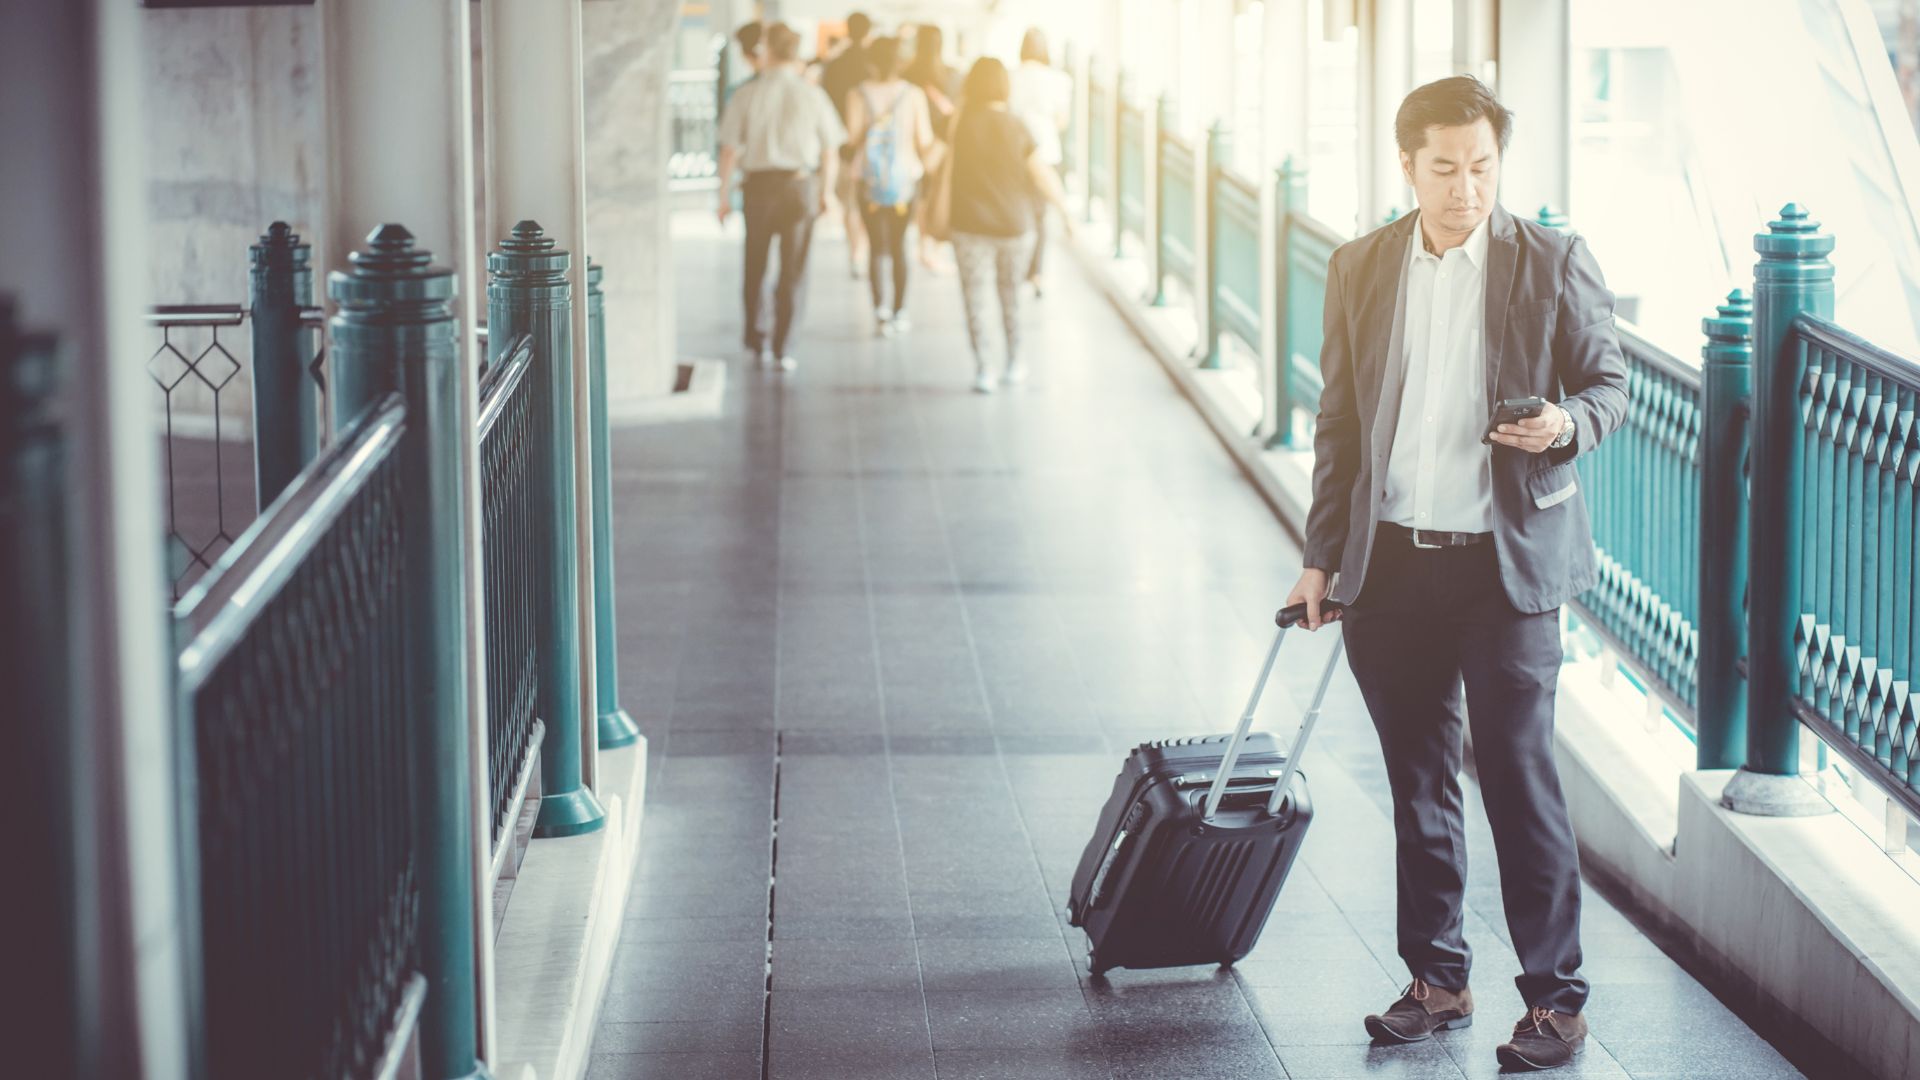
[1304,206,1626,611]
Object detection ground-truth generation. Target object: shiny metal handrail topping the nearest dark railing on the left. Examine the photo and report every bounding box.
[175,394,407,694]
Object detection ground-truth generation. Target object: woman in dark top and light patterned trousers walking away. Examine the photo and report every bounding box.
[935,58,1073,394]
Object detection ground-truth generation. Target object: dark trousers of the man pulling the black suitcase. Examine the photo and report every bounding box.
[1344,527,1588,1013]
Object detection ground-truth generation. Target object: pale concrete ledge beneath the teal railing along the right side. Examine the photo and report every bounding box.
[1069,229,1920,1080]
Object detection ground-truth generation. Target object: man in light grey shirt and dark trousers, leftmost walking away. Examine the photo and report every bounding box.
[720,23,847,371]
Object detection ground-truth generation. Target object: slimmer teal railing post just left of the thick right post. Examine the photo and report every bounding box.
[1704,290,1753,769]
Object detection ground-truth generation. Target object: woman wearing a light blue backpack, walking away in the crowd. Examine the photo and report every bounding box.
[845,38,933,336]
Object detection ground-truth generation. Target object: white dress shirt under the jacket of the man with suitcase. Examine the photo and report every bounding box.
[1380,217,1494,532]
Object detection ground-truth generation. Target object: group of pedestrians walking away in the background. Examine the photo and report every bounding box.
[718,12,1071,394]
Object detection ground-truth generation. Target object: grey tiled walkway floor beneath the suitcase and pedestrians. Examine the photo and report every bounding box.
[591,223,1797,1080]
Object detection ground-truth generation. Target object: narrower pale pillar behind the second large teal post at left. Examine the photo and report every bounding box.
[482,0,599,788]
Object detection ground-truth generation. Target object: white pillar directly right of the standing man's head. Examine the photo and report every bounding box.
[1496,0,1572,215]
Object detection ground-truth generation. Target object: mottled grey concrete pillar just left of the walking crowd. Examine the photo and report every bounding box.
[576,0,683,405]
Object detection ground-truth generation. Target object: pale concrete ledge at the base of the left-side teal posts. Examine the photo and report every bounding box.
[493,738,647,1080]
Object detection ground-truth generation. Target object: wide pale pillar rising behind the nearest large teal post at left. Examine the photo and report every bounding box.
[321,0,493,1072]
